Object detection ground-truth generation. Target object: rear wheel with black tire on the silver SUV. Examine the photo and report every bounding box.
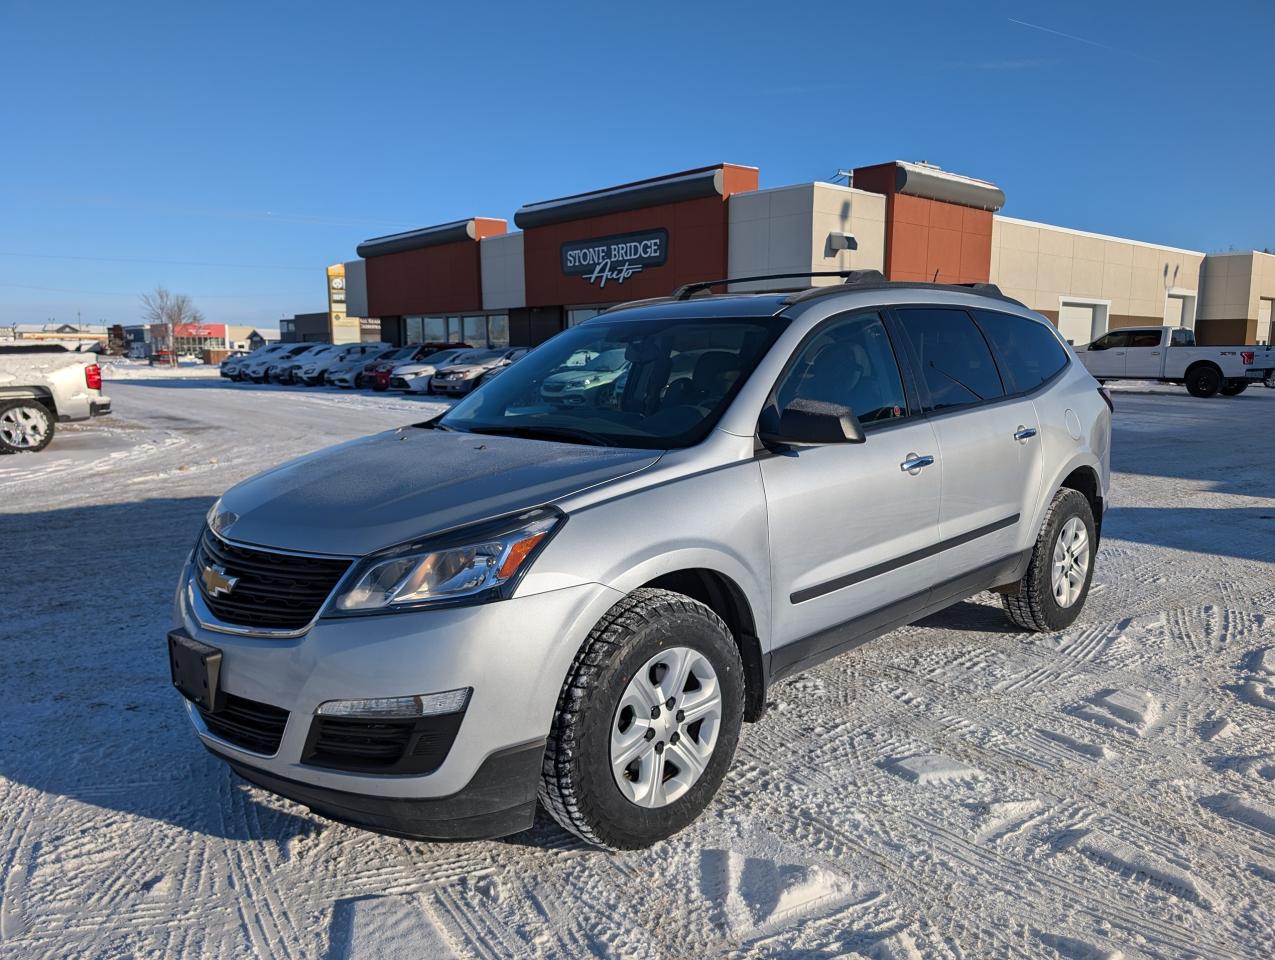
[1001,488,1098,634]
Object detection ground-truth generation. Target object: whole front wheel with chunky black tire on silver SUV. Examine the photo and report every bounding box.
[539,588,743,850]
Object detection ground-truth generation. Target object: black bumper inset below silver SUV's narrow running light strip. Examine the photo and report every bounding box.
[301,711,464,774]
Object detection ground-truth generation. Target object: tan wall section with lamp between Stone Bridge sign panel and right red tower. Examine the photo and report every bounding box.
[727,184,886,289]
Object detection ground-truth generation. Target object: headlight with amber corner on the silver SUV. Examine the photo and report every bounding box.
[333,509,565,615]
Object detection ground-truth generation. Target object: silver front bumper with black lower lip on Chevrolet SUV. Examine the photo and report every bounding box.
[176,571,621,836]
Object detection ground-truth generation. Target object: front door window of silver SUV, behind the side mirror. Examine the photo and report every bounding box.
[775,314,908,426]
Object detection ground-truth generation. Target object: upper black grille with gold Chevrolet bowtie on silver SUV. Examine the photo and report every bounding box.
[195,527,349,630]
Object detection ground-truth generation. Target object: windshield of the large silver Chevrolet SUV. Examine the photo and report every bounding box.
[437,317,787,450]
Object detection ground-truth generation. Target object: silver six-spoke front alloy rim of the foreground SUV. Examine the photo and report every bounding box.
[611,646,722,808]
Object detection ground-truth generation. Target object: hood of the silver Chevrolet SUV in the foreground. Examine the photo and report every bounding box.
[222,427,660,556]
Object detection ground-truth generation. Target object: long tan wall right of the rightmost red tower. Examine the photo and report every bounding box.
[992,217,1204,329]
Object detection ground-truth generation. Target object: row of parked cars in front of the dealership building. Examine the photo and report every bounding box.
[221,343,527,395]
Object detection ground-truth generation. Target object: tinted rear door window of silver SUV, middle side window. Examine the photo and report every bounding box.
[899,310,1005,411]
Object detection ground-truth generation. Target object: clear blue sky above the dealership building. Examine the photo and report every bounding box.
[0,0,1275,326]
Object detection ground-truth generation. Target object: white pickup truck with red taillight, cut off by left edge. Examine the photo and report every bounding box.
[0,342,111,454]
